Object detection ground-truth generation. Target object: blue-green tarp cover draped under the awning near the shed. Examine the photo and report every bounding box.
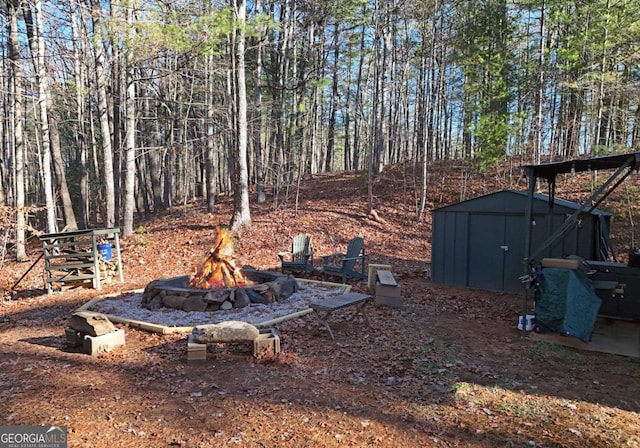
[535,268,602,342]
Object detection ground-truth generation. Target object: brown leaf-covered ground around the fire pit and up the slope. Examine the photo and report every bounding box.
[0,164,640,448]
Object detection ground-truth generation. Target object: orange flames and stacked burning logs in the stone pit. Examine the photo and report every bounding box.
[189,226,248,289]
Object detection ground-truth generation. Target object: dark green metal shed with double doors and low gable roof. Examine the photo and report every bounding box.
[431,190,611,292]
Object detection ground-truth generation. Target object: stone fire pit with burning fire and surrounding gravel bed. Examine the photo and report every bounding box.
[80,224,350,333]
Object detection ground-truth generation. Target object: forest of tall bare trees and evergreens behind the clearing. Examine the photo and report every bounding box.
[0,0,640,260]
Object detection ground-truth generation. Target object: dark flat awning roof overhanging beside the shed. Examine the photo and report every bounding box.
[523,152,640,181]
